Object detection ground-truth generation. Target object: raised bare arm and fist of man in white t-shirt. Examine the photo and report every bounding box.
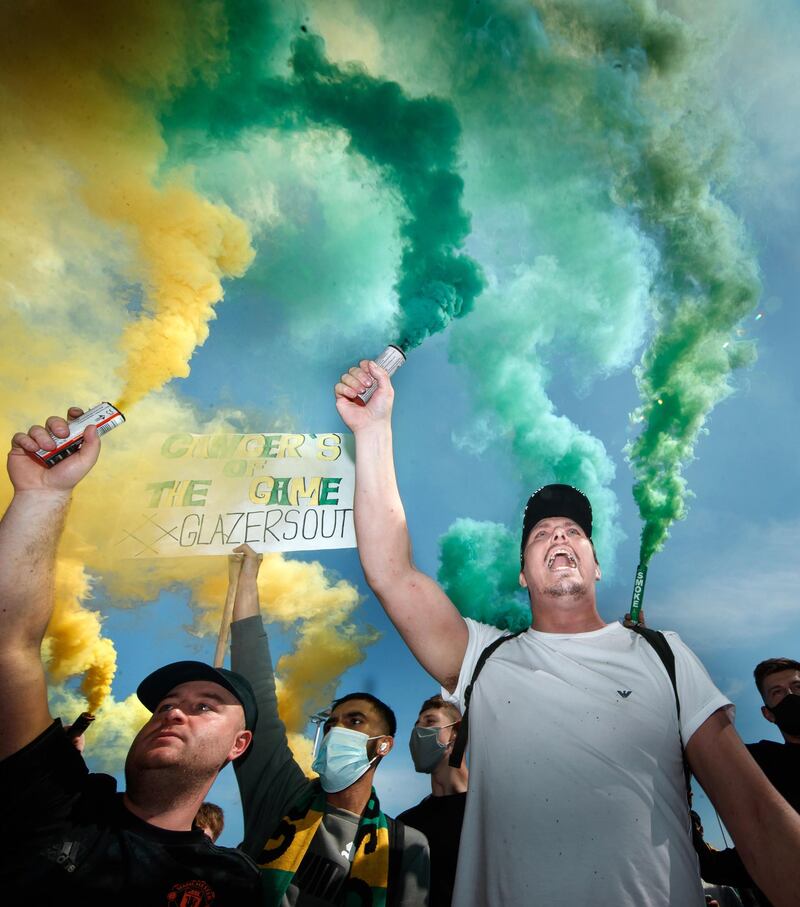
[335,360,467,691]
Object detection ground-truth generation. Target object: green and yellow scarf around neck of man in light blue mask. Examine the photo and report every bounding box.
[259,783,389,907]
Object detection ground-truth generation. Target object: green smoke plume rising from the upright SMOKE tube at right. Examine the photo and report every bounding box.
[629,151,760,564]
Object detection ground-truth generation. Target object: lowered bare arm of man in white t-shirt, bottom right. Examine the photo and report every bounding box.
[686,710,800,907]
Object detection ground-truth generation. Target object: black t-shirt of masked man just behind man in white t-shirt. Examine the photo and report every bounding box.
[397,793,467,907]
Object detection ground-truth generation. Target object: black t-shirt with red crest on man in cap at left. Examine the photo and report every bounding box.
[0,721,259,907]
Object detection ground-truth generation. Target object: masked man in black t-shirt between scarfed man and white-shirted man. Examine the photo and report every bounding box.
[397,696,469,907]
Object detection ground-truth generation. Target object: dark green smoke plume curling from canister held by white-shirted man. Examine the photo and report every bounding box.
[278,35,483,349]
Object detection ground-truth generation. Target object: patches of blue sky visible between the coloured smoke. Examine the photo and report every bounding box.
[94,250,800,844]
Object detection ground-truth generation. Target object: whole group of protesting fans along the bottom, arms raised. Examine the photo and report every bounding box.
[0,382,800,907]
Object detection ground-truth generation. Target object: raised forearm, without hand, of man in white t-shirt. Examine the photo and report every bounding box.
[354,424,412,594]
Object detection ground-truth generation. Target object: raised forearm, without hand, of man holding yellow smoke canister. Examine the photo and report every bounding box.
[0,491,71,656]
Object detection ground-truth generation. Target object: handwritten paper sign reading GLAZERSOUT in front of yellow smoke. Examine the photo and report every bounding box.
[115,433,356,558]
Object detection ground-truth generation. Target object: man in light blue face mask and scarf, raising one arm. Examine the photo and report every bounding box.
[231,545,429,907]
